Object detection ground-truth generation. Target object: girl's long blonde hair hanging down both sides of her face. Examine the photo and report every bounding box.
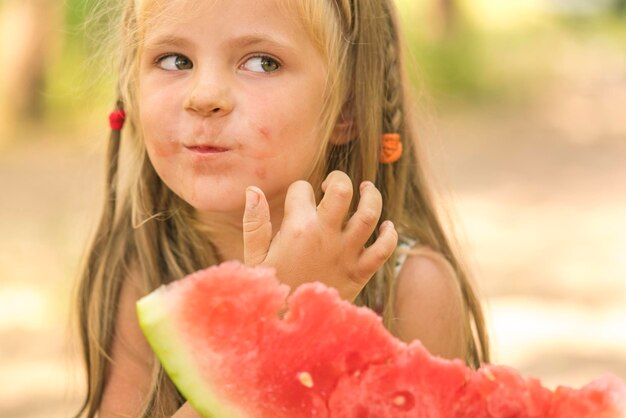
[78,0,489,417]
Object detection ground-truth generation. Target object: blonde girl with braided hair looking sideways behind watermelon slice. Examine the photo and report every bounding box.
[79,0,488,418]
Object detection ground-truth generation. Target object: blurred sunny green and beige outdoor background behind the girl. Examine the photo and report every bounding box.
[0,0,626,418]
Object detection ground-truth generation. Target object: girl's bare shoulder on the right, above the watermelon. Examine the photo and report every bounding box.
[394,248,467,358]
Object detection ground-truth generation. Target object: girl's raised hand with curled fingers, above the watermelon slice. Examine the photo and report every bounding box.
[243,171,398,301]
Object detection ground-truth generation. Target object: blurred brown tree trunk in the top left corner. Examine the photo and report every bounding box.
[0,0,62,143]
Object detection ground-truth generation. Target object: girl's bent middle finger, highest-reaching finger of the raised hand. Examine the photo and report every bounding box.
[317,171,352,228]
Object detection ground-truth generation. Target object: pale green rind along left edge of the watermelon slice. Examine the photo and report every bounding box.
[137,286,247,418]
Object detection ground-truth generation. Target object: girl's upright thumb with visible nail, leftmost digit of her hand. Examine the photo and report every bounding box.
[243,186,272,266]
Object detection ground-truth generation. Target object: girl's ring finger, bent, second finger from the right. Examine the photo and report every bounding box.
[346,181,383,243]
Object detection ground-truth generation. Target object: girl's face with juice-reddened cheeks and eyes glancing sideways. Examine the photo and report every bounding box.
[138,0,327,220]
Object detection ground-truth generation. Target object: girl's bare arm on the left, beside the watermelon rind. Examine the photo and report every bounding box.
[98,280,200,418]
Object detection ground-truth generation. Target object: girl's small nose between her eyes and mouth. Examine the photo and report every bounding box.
[184,71,233,117]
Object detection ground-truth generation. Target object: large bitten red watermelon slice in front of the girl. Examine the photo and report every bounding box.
[137,262,626,418]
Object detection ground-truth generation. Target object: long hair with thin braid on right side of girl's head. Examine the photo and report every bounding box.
[324,0,489,367]
